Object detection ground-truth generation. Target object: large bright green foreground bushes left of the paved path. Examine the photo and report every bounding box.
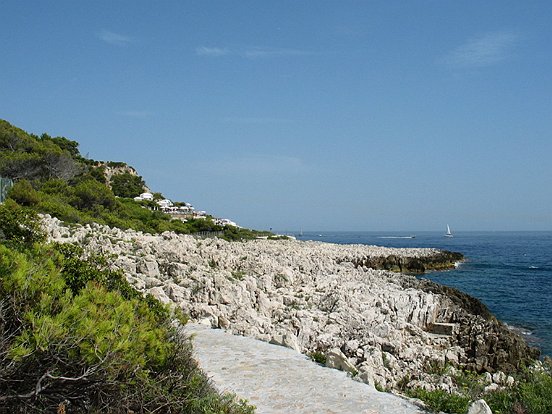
[0,201,253,413]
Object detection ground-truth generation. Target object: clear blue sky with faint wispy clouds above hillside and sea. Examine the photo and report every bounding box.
[0,0,552,231]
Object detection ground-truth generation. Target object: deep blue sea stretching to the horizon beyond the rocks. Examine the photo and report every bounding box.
[295,232,552,356]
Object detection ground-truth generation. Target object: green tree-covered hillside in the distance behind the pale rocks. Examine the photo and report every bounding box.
[0,120,271,241]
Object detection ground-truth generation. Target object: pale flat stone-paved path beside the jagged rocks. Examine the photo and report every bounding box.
[185,324,422,414]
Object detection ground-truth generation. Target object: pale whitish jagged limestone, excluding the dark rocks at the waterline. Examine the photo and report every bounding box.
[40,218,492,396]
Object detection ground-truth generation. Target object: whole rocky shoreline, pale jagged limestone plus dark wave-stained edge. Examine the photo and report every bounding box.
[44,216,538,391]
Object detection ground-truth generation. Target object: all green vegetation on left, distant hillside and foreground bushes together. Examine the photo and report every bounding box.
[0,120,264,414]
